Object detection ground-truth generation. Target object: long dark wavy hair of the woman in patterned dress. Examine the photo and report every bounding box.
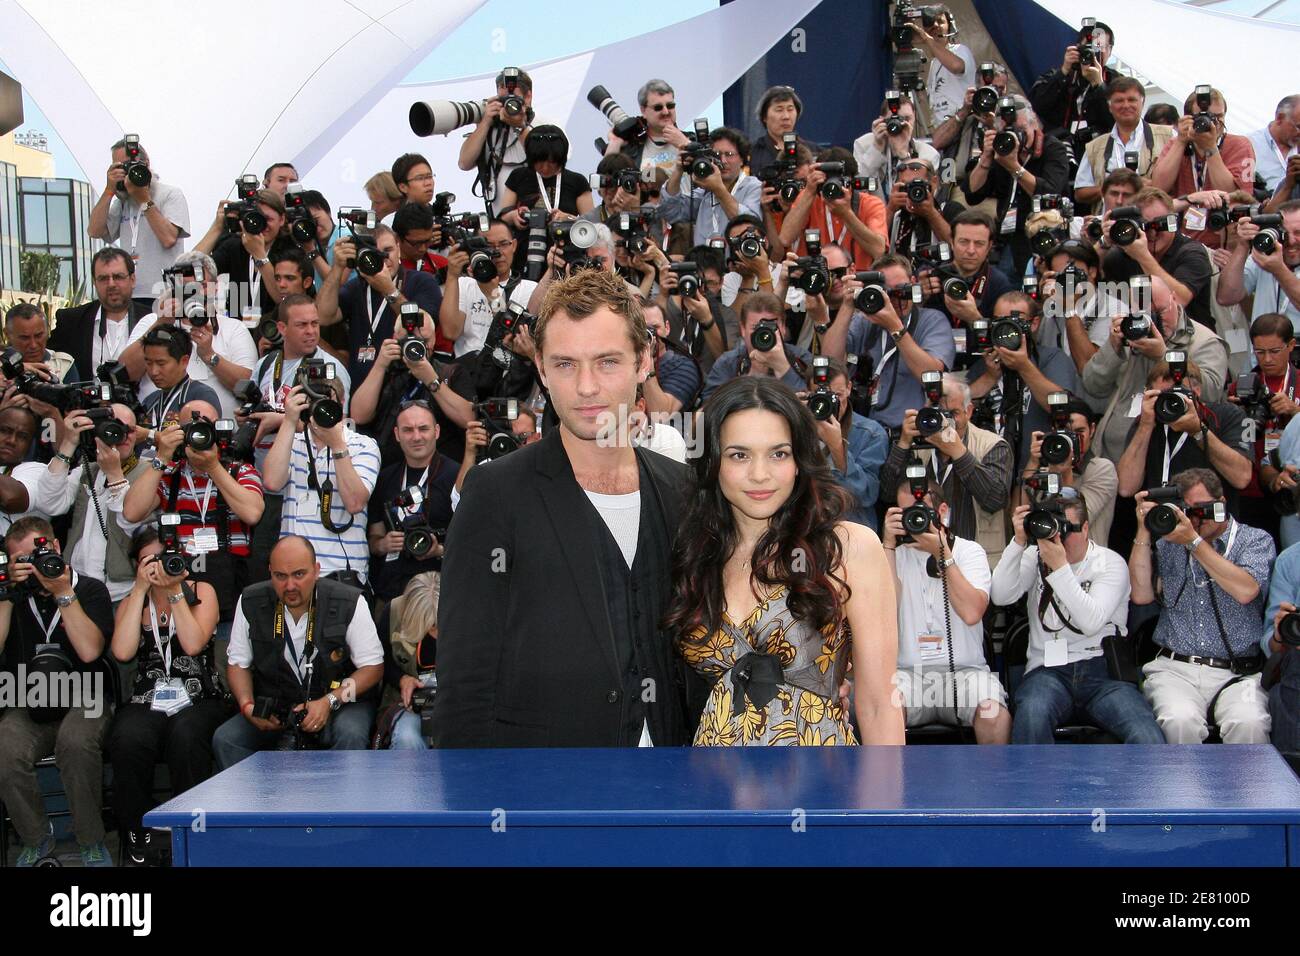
[663,376,852,640]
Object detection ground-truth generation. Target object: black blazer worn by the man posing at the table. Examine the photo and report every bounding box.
[433,428,698,747]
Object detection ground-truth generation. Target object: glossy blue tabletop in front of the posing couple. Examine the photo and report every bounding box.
[147,745,1300,827]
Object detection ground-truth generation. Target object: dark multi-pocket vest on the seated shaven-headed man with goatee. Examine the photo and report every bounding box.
[243,578,361,704]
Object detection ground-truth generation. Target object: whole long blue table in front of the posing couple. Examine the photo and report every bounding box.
[144,745,1300,866]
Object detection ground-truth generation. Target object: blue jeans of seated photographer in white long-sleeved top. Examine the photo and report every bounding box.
[1011,654,1165,744]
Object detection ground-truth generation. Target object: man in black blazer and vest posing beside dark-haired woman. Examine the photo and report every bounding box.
[434,271,702,747]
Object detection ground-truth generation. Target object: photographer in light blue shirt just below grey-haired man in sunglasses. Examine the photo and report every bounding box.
[659,126,763,246]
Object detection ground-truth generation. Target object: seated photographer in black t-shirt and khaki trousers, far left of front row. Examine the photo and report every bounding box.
[0,515,113,866]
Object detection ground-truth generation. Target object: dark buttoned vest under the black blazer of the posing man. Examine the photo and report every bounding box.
[590,455,679,747]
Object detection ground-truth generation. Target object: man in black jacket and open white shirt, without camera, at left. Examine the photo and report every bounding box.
[49,246,148,377]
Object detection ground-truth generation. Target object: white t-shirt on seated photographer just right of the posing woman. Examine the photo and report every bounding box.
[894,537,993,670]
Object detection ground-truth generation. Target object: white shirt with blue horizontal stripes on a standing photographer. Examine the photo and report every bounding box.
[280,429,380,581]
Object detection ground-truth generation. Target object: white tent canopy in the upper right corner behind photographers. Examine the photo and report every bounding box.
[1035,0,1300,134]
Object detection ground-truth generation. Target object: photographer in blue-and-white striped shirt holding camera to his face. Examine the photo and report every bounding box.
[262,378,380,587]
